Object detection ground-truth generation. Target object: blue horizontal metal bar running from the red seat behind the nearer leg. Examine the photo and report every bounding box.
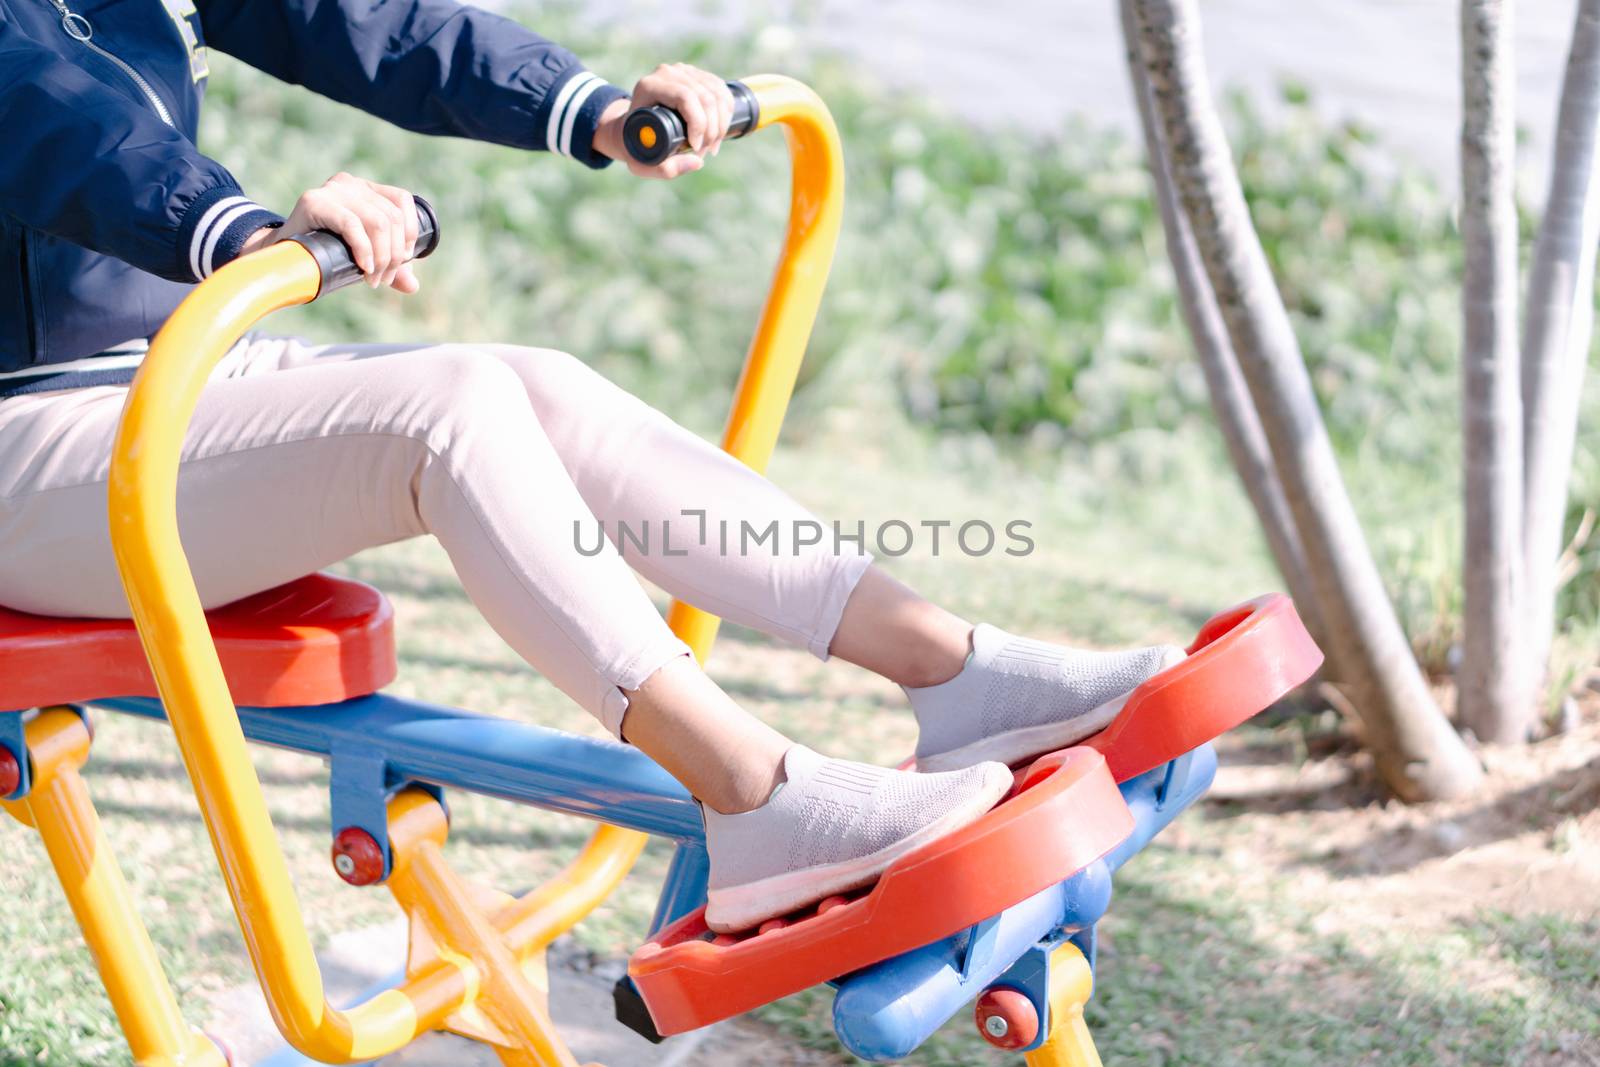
[96,693,704,843]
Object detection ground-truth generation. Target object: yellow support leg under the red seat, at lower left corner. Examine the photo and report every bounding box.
[0,707,227,1067]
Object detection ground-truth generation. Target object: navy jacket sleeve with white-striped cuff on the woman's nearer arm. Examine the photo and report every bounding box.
[0,14,282,282]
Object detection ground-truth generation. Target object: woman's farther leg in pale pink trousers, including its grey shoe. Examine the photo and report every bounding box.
[240,346,1182,769]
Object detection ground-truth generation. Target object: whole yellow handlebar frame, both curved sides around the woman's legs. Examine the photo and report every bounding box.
[110,75,845,1062]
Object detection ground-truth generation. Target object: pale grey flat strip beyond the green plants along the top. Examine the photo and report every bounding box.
[586,0,1576,200]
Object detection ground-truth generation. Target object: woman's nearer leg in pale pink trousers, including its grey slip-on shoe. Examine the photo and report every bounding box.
[0,343,1010,928]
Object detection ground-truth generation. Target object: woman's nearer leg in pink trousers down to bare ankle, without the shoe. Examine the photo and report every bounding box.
[0,344,787,811]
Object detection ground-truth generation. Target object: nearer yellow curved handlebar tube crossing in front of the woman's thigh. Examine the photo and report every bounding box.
[110,242,444,1062]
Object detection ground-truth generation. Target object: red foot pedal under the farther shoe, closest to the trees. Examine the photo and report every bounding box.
[1082,593,1322,782]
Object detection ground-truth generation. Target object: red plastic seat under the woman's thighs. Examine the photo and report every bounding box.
[0,574,397,710]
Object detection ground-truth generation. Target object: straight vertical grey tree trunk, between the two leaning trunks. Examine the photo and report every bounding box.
[1458,0,1533,742]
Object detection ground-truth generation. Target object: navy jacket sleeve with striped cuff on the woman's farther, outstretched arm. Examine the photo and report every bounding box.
[198,0,627,168]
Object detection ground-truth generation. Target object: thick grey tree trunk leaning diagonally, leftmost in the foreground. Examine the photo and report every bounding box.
[1133,0,1482,800]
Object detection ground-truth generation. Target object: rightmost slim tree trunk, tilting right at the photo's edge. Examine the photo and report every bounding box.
[1522,0,1600,700]
